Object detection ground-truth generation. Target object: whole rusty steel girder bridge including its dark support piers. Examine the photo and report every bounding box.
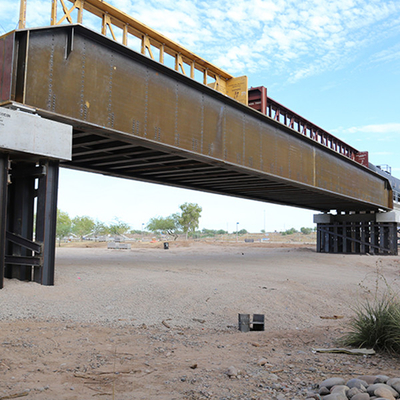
[0,7,397,285]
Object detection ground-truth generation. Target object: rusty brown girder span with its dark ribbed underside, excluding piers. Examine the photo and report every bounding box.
[1,26,391,210]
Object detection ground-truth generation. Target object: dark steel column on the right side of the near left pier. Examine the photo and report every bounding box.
[34,161,59,285]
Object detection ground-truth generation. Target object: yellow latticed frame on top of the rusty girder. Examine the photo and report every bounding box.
[44,0,247,104]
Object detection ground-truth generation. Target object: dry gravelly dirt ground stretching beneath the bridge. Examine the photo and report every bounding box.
[0,242,400,400]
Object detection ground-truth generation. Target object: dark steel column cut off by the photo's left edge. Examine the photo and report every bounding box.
[0,153,8,289]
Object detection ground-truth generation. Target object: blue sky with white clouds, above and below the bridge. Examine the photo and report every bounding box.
[0,0,400,232]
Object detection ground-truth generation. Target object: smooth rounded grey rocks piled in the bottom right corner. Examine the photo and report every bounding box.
[307,375,400,400]
